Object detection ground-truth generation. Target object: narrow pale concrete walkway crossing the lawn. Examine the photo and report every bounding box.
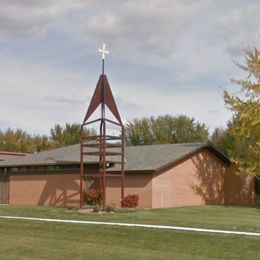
[0,216,260,237]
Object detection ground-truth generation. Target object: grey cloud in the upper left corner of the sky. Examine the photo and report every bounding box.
[0,0,92,38]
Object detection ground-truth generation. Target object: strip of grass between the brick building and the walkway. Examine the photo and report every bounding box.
[0,205,260,232]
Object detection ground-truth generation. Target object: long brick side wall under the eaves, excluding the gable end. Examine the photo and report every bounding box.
[9,173,152,208]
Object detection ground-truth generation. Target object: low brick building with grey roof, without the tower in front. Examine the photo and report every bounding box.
[0,143,259,208]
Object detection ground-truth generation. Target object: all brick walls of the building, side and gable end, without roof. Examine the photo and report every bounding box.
[10,149,255,208]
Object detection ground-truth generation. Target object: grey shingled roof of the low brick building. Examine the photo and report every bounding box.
[0,143,230,171]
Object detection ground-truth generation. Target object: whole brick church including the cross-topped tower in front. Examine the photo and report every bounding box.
[0,45,260,208]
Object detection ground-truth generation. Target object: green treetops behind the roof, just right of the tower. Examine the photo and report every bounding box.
[126,115,209,145]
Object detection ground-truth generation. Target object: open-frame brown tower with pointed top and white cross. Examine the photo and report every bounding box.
[80,44,125,209]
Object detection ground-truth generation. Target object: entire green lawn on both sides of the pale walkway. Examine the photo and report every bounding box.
[0,206,260,259]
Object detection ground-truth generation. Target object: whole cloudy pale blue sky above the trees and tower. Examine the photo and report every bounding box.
[0,0,260,134]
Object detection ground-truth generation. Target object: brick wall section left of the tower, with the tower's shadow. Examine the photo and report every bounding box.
[9,174,79,206]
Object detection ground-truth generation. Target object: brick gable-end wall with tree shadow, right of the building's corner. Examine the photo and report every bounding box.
[152,149,255,208]
